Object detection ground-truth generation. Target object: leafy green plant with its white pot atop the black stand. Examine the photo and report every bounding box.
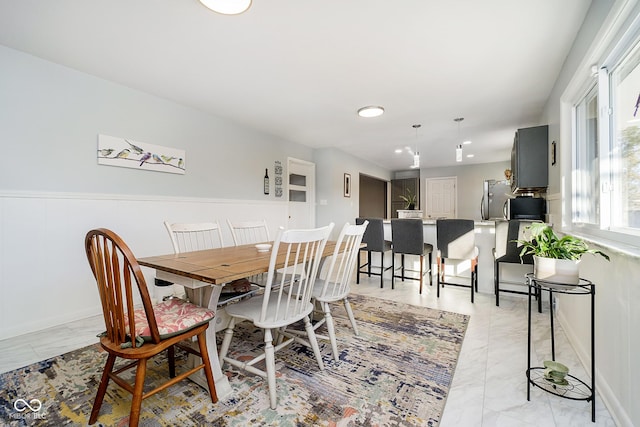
[517,222,609,285]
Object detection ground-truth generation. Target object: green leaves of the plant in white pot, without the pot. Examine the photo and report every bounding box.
[516,222,609,261]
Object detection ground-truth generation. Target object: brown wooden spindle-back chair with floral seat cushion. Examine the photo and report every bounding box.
[85,228,218,427]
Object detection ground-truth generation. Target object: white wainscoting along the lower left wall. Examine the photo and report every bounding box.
[0,192,287,339]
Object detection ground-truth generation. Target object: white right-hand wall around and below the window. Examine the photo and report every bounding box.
[541,0,640,426]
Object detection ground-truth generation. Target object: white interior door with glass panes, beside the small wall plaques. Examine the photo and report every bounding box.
[287,158,316,228]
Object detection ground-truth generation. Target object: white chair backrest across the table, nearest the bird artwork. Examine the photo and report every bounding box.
[164,221,224,254]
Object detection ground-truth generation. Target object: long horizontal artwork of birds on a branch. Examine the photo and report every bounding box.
[98,135,186,175]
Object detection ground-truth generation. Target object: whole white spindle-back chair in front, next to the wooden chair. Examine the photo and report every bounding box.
[220,223,333,409]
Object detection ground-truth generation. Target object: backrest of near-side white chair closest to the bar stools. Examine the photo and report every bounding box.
[320,220,369,301]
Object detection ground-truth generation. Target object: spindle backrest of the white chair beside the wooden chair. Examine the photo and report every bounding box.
[256,223,333,328]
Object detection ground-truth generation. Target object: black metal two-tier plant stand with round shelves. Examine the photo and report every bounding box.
[526,273,596,422]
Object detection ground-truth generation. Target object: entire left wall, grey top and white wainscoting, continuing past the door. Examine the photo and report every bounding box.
[0,46,390,339]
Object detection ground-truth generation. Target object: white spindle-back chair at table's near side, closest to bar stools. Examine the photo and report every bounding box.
[283,220,369,362]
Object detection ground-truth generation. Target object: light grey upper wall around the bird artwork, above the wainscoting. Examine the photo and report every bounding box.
[0,46,313,200]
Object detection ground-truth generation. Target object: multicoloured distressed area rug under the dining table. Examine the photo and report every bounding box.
[0,295,469,426]
